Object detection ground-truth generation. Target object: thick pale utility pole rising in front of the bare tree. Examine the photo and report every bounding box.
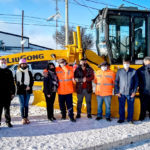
[65,0,68,45]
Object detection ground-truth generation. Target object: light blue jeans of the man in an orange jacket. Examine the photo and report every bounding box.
[97,96,111,118]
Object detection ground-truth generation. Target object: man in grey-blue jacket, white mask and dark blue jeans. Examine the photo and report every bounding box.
[115,58,138,123]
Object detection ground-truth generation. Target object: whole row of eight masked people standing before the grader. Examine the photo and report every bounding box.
[0,57,150,127]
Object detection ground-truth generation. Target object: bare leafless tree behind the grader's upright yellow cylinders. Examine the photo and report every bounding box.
[53,26,93,49]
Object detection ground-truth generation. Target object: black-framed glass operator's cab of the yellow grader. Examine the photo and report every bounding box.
[93,7,150,64]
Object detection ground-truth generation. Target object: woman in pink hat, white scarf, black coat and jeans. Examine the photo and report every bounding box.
[15,59,34,124]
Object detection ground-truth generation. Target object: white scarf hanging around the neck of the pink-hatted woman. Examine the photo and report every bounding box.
[16,68,30,86]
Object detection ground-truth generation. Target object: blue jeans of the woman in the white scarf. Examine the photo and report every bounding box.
[19,94,30,118]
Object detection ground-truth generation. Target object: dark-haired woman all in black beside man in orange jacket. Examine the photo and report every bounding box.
[43,63,58,121]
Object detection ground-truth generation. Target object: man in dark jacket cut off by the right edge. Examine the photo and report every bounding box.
[137,57,150,121]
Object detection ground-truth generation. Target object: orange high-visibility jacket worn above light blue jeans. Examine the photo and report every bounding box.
[94,70,115,96]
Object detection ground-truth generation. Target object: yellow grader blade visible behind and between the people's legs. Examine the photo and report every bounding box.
[33,90,140,120]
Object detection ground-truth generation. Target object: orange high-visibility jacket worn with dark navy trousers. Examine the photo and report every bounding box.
[56,65,74,95]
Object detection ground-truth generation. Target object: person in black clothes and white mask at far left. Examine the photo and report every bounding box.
[0,58,15,127]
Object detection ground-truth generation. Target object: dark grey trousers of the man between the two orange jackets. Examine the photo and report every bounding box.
[77,89,92,115]
